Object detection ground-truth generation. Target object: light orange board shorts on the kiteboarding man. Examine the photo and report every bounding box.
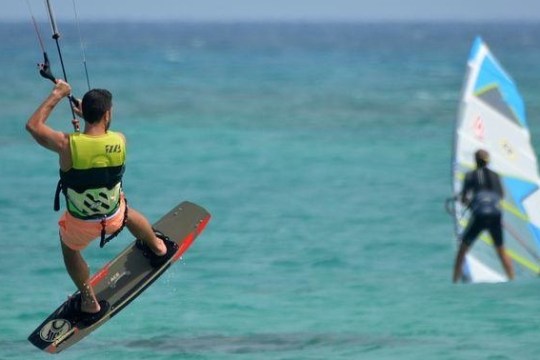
[58,196,126,251]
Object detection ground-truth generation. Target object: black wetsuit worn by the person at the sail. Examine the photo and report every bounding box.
[461,167,504,247]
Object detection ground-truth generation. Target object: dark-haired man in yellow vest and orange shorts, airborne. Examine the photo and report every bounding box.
[26,79,178,321]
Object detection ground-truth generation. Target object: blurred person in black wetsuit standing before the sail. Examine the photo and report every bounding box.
[453,149,514,282]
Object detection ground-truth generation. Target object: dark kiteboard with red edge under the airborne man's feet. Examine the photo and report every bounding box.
[28,201,210,353]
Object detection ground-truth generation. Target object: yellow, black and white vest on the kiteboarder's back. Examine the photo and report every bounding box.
[55,131,126,220]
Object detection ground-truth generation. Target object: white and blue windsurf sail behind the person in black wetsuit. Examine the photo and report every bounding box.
[452,37,540,282]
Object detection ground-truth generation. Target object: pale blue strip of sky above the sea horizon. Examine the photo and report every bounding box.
[6,0,540,22]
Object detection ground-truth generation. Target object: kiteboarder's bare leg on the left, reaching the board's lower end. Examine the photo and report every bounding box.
[60,241,101,313]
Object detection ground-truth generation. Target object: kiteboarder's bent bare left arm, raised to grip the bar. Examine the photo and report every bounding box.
[26,80,71,153]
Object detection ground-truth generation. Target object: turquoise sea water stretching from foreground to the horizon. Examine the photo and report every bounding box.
[0,22,540,360]
